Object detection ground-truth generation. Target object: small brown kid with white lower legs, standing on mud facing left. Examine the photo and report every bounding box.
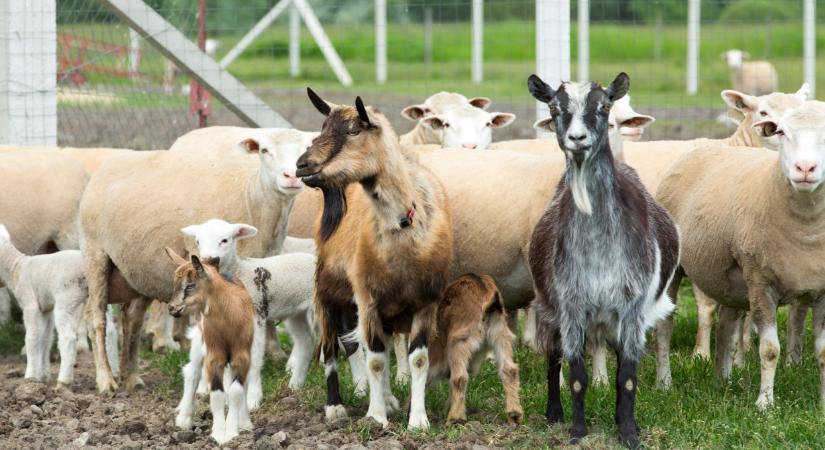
[166,248,254,444]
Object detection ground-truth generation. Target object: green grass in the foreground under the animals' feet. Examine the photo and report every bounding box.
[6,285,825,449]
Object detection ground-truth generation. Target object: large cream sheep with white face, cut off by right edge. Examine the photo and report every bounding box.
[656,101,825,409]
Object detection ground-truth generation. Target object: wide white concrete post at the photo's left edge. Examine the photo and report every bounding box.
[0,0,57,146]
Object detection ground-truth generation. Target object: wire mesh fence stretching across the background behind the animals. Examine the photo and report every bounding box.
[33,0,825,149]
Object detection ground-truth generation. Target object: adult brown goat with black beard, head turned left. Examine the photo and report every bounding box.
[298,89,453,429]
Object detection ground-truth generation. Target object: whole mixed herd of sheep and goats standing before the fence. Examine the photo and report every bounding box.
[0,59,825,447]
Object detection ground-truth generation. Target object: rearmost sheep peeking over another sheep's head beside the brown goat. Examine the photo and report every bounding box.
[399,91,491,145]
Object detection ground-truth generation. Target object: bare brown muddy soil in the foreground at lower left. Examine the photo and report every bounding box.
[0,353,604,450]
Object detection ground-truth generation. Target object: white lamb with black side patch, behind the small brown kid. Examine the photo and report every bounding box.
[176,219,328,426]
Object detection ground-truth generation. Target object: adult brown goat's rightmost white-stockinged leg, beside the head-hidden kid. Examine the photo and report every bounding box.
[407,302,438,430]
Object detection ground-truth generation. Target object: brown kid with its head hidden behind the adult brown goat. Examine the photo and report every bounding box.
[429,274,524,424]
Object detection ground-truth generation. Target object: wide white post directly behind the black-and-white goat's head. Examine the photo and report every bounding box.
[536,0,570,137]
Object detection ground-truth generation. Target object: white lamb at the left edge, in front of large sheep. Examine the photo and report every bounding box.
[0,224,88,387]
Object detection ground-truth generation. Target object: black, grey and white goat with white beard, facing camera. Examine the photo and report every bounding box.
[527,73,679,447]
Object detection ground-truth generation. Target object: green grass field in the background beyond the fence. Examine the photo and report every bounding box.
[60,21,825,107]
